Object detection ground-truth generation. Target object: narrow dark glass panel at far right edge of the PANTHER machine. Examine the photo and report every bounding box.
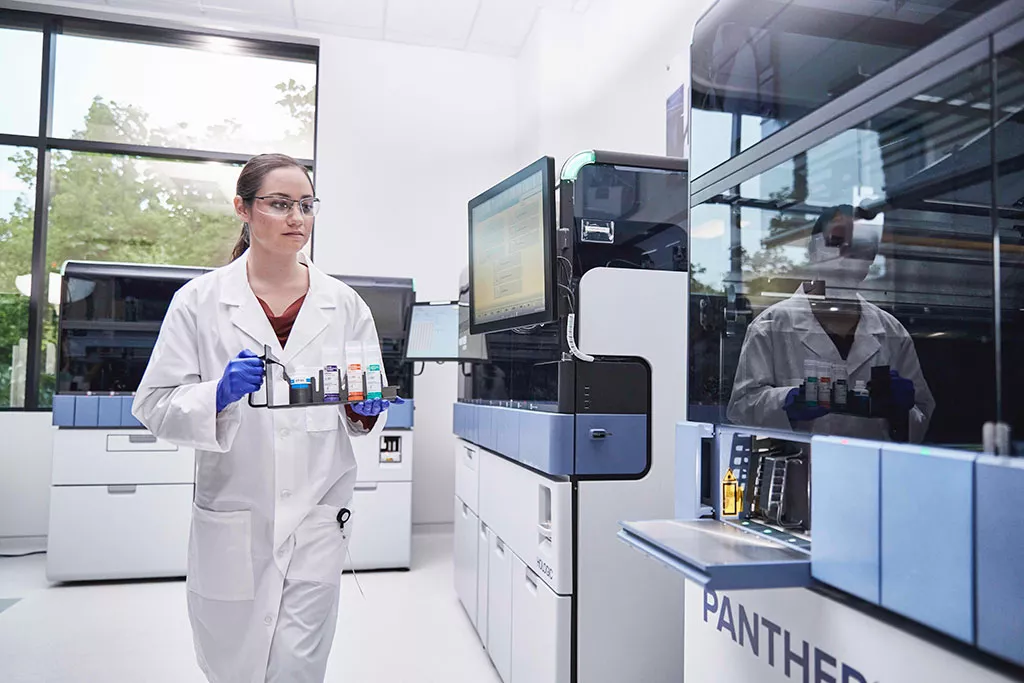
[995,44,1024,439]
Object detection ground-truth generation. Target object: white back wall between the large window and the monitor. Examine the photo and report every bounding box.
[313,38,516,524]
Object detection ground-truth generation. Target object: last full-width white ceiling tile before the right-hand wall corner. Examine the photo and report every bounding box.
[385,0,480,48]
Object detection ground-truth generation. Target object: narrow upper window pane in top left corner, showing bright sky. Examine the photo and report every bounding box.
[0,29,43,136]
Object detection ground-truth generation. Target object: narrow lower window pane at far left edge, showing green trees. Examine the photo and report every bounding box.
[0,145,36,408]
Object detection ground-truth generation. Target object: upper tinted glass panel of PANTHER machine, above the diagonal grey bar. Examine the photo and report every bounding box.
[690,0,1000,177]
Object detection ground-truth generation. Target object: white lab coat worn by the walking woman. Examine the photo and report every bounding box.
[132,256,384,683]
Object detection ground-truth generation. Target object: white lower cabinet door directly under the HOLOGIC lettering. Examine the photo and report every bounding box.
[511,556,572,683]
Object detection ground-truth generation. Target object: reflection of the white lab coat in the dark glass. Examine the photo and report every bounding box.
[728,292,935,443]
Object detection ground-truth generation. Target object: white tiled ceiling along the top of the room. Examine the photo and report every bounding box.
[41,0,591,57]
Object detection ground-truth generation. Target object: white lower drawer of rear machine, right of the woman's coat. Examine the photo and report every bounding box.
[345,481,413,569]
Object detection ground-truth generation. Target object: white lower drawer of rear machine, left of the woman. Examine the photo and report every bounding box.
[46,483,193,581]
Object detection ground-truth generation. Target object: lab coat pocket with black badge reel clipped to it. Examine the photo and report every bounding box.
[288,505,354,586]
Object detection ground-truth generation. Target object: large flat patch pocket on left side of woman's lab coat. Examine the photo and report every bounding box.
[185,505,255,601]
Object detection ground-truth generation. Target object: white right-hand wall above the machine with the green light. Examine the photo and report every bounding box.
[516,0,709,165]
